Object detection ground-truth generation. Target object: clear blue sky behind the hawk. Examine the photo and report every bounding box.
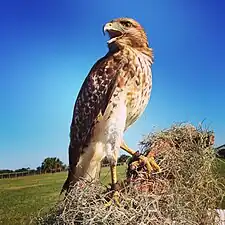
[0,0,225,169]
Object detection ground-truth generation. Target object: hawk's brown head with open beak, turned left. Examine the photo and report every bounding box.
[103,18,148,48]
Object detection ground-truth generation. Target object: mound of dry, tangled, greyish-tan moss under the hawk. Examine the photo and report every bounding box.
[39,125,224,225]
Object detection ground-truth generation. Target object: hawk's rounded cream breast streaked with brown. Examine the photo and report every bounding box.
[126,53,152,127]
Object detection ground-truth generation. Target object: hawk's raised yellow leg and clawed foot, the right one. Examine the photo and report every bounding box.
[120,141,160,173]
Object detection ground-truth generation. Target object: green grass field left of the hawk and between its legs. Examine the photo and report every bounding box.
[0,166,125,225]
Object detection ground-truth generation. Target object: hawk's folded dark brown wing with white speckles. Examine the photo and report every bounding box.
[61,53,123,193]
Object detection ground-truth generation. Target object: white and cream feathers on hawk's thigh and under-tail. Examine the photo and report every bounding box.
[75,89,127,180]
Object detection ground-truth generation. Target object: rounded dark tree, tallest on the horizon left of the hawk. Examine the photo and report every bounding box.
[41,157,65,173]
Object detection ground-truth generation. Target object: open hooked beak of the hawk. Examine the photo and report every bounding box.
[103,22,124,42]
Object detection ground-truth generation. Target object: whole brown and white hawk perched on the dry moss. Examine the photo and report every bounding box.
[62,18,159,203]
